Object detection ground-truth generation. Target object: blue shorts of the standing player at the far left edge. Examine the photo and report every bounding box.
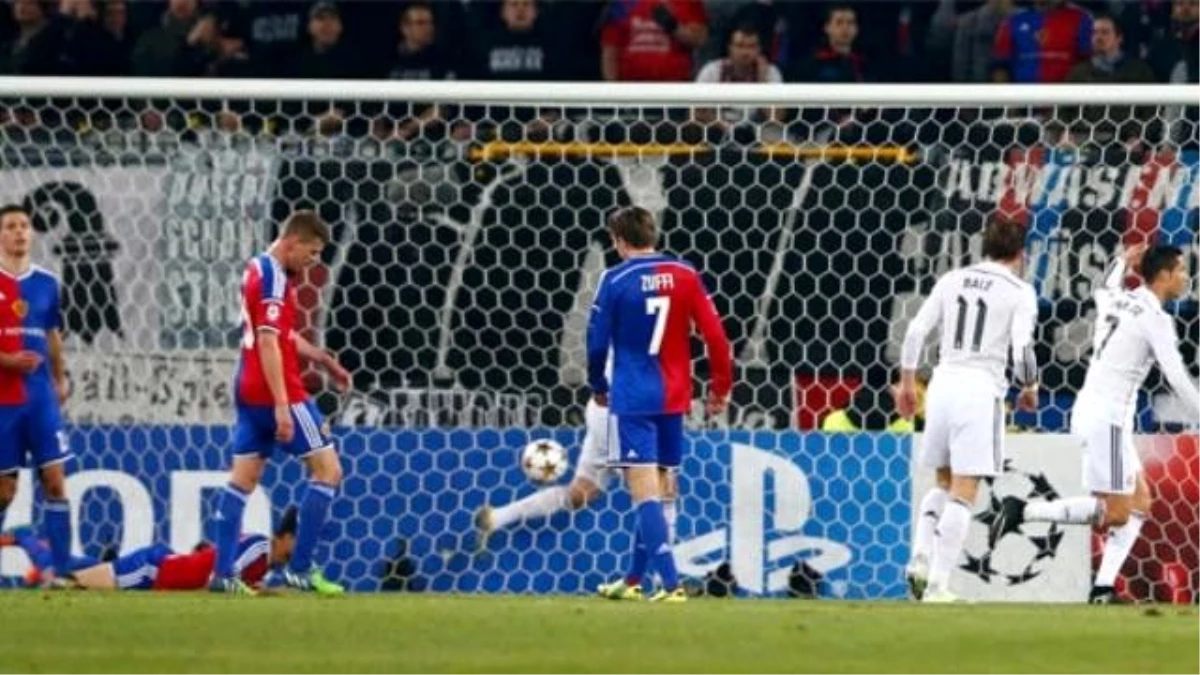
[0,401,71,474]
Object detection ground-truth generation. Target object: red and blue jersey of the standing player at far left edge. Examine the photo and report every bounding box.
[0,265,62,406]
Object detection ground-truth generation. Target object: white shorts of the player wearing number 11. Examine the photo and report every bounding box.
[920,374,1004,476]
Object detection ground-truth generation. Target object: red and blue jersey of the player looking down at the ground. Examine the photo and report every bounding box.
[236,253,308,406]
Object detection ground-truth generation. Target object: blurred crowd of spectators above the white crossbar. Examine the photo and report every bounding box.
[0,0,1200,82]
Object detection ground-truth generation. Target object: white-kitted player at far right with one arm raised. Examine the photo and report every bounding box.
[991,245,1200,604]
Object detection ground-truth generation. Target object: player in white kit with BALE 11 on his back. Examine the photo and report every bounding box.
[898,220,1038,602]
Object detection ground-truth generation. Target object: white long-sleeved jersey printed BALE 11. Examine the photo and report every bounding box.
[900,262,1038,394]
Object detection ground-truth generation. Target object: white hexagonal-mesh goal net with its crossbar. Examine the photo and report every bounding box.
[0,78,1200,599]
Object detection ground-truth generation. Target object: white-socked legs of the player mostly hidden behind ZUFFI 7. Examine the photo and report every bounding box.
[475,399,677,548]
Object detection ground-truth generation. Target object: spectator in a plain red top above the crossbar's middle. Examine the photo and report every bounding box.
[600,0,708,82]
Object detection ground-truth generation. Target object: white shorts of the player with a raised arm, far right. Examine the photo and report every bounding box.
[1070,416,1141,495]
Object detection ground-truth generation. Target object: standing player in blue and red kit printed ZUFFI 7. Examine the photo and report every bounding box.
[587,207,733,602]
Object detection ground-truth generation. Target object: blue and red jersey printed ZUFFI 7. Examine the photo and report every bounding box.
[587,253,733,414]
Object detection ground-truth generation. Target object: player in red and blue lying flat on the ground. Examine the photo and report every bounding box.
[0,507,296,591]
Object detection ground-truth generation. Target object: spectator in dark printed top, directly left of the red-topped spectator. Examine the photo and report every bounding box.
[469,0,558,80]
